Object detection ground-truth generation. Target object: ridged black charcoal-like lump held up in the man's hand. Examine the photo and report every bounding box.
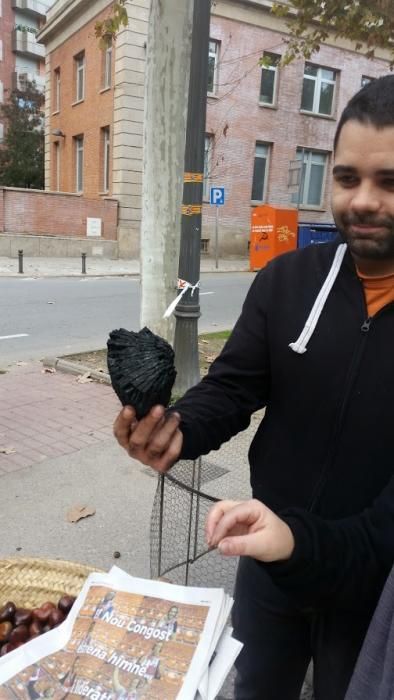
[107,327,176,420]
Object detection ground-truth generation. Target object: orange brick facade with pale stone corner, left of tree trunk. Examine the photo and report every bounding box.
[39,0,149,256]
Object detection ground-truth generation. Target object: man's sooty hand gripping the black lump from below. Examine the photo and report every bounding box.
[114,406,183,473]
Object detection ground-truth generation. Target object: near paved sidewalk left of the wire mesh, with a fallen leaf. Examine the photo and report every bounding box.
[0,362,157,577]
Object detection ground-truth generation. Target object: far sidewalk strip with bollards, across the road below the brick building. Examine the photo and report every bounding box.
[0,257,249,278]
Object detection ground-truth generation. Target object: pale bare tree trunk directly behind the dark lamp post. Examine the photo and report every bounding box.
[141,0,193,342]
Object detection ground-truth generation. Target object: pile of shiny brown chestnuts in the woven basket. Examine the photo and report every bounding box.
[0,595,75,656]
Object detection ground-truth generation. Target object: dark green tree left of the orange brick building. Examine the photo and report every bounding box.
[0,83,44,190]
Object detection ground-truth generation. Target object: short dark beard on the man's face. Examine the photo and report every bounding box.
[334,214,394,260]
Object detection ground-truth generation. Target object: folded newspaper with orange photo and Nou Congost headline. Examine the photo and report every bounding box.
[0,567,242,700]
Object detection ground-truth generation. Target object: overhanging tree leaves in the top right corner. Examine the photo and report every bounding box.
[272,0,394,68]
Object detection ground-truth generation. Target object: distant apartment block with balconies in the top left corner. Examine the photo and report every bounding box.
[0,0,48,139]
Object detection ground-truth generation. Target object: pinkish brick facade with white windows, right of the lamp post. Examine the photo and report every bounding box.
[203,0,389,253]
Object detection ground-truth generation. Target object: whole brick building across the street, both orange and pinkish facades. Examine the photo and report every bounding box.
[37,0,389,256]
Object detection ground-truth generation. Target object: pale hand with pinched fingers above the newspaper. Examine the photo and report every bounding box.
[205,499,294,562]
